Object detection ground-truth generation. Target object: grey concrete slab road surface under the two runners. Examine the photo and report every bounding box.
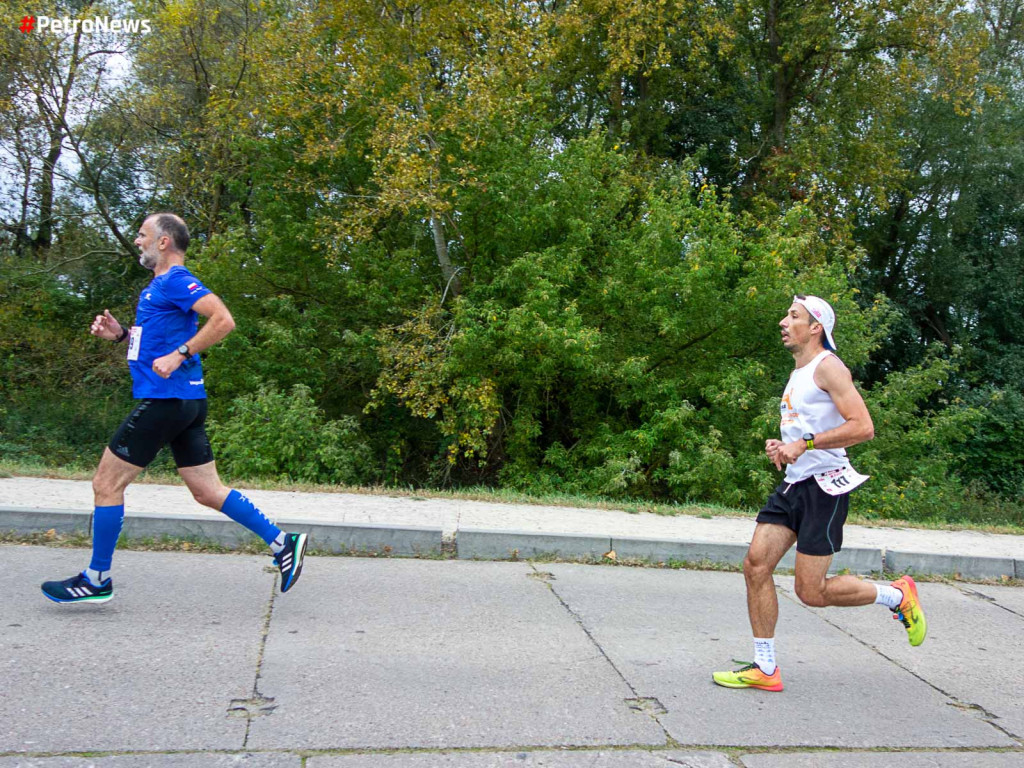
[0,545,1024,768]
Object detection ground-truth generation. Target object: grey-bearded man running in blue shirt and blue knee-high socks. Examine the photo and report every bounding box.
[43,213,306,603]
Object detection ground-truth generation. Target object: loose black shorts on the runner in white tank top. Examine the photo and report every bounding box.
[758,477,850,555]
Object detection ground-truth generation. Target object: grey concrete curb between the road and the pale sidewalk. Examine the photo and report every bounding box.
[0,507,1024,579]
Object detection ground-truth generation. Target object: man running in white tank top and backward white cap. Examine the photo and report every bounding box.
[713,296,927,691]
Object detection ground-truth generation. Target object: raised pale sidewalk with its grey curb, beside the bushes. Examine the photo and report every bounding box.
[0,477,1024,579]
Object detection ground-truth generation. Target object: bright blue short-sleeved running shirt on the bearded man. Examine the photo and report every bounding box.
[128,265,212,400]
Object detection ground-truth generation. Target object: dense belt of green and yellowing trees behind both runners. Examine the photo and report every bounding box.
[0,0,1024,519]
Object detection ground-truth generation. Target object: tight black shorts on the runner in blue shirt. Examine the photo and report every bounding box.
[109,397,213,468]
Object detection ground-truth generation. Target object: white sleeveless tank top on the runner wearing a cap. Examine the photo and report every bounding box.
[779,349,850,482]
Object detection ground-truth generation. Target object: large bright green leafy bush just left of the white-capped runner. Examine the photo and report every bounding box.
[374,135,884,503]
